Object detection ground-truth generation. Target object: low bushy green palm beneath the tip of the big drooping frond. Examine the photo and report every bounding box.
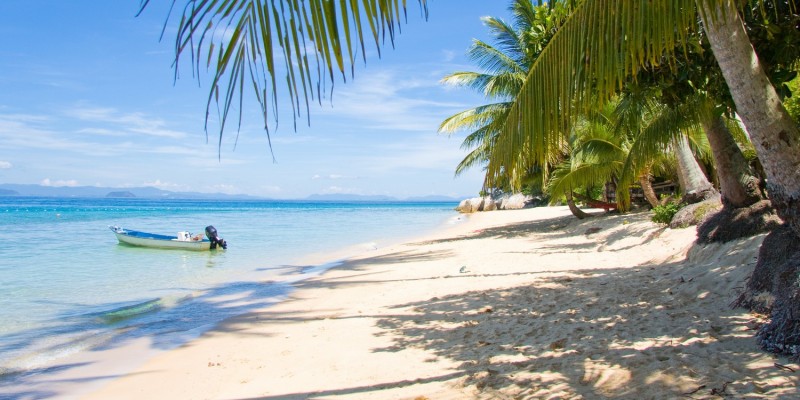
[548,95,716,217]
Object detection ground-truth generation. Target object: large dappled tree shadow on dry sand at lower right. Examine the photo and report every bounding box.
[376,255,798,399]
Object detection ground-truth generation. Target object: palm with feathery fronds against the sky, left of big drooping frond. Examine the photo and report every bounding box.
[439,0,569,186]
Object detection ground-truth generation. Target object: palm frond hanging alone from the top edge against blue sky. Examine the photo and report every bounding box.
[140,0,428,156]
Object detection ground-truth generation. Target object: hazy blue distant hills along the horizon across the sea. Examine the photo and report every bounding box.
[0,183,461,203]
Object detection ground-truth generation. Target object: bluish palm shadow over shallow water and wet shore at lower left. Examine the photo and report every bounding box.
[0,282,290,399]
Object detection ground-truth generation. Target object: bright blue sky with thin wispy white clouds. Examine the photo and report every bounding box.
[0,0,509,199]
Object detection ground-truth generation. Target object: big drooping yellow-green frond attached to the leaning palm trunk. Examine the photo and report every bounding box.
[487,0,697,185]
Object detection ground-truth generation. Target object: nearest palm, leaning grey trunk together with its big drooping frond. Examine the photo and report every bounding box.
[488,0,800,235]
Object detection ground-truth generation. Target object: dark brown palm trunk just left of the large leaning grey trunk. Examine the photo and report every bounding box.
[703,116,762,208]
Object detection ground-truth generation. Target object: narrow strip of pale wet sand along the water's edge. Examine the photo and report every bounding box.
[0,206,463,399]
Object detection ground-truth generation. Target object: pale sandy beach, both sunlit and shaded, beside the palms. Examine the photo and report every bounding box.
[67,207,800,399]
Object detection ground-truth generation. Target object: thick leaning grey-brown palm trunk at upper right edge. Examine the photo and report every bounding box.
[696,0,800,236]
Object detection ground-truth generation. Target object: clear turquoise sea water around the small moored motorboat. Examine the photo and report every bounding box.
[0,197,457,376]
